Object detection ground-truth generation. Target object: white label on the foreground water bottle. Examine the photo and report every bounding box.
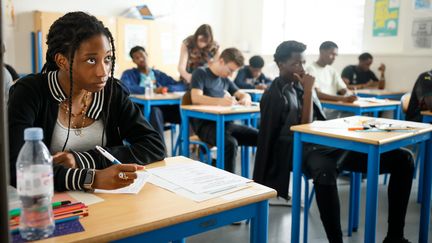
[17,165,54,196]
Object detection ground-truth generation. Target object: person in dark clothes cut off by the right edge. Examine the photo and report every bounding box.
[406,71,432,122]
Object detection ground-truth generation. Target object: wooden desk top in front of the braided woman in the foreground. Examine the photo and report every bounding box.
[40,156,276,243]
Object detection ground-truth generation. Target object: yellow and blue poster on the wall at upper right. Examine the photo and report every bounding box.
[372,0,400,37]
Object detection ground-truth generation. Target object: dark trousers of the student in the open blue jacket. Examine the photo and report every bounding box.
[150,105,181,143]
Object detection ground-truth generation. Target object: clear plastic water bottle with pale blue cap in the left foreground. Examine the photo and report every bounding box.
[16,127,55,240]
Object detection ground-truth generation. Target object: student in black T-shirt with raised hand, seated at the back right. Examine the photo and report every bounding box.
[342,52,385,89]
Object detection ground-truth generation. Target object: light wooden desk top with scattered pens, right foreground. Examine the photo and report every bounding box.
[291,116,432,145]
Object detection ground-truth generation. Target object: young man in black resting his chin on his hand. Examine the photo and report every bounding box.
[253,41,414,243]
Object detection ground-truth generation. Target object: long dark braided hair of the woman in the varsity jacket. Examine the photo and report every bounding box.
[41,12,115,151]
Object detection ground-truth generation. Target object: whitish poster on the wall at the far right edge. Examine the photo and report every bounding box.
[411,18,432,49]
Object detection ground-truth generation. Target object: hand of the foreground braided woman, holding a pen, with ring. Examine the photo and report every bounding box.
[92,164,144,190]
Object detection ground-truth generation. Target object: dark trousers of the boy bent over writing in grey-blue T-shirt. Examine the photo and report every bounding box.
[194,121,258,173]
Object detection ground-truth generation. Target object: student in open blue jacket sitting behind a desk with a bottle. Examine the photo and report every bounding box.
[120,46,186,142]
